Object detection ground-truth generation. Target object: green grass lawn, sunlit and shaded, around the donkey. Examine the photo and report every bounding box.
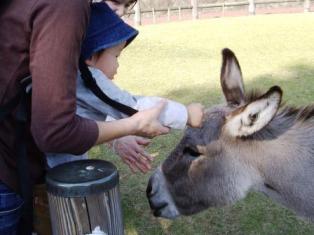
[91,13,314,235]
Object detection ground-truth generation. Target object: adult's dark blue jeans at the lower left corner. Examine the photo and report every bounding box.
[0,181,23,235]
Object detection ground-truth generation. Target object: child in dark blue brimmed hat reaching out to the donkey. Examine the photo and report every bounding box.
[48,3,203,172]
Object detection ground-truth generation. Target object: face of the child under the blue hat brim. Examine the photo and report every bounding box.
[91,42,126,80]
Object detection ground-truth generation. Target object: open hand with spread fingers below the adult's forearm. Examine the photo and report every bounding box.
[112,136,153,173]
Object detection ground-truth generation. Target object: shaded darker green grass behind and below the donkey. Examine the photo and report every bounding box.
[121,63,314,235]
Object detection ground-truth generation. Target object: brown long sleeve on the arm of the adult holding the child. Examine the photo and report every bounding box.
[29,0,98,154]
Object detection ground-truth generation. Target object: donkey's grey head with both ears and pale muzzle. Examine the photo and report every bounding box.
[147,49,282,218]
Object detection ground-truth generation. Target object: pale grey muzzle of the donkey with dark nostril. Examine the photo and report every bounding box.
[146,167,180,219]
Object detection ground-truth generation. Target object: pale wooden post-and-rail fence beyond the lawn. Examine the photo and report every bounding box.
[130,0,313,25]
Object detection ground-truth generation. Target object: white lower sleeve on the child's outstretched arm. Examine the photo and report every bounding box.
[136,96,188,130]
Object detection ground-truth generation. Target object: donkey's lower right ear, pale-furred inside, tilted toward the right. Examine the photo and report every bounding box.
[224,86,282,137]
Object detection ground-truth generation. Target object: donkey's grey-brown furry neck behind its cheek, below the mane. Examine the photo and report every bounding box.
[233,119,314,218]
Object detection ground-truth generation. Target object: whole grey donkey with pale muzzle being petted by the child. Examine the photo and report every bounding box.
[147,49,314,220]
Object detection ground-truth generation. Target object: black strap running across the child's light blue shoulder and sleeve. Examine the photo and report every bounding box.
[79,59,138,116]
